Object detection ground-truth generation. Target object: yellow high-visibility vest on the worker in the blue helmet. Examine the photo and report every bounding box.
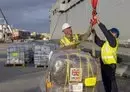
[101,39,119,64]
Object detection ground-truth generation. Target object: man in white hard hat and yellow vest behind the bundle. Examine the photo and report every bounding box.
[60,23,91,49]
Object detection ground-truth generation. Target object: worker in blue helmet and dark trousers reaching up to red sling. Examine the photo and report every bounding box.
[92,16,119,92]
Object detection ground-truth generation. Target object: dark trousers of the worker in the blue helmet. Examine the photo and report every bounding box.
[101,63,118,92]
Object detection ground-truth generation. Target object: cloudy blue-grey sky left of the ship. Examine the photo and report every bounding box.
[0,0,56,32]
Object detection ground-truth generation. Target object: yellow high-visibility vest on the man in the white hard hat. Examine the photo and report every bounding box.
[60,34,79,47]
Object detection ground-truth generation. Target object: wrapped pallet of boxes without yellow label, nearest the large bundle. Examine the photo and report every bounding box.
[34,43,58,68]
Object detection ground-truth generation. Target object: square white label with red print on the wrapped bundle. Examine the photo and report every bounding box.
[70,68,82,81]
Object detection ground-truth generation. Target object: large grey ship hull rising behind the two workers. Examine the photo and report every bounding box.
[50,0,130,56]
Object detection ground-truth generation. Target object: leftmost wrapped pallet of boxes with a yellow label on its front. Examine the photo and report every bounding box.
[5,44,25,66]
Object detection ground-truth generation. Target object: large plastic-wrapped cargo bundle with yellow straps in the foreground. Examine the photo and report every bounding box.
[42,50,104,92]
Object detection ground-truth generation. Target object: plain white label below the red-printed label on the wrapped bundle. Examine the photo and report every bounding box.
[69,83,83,92]
